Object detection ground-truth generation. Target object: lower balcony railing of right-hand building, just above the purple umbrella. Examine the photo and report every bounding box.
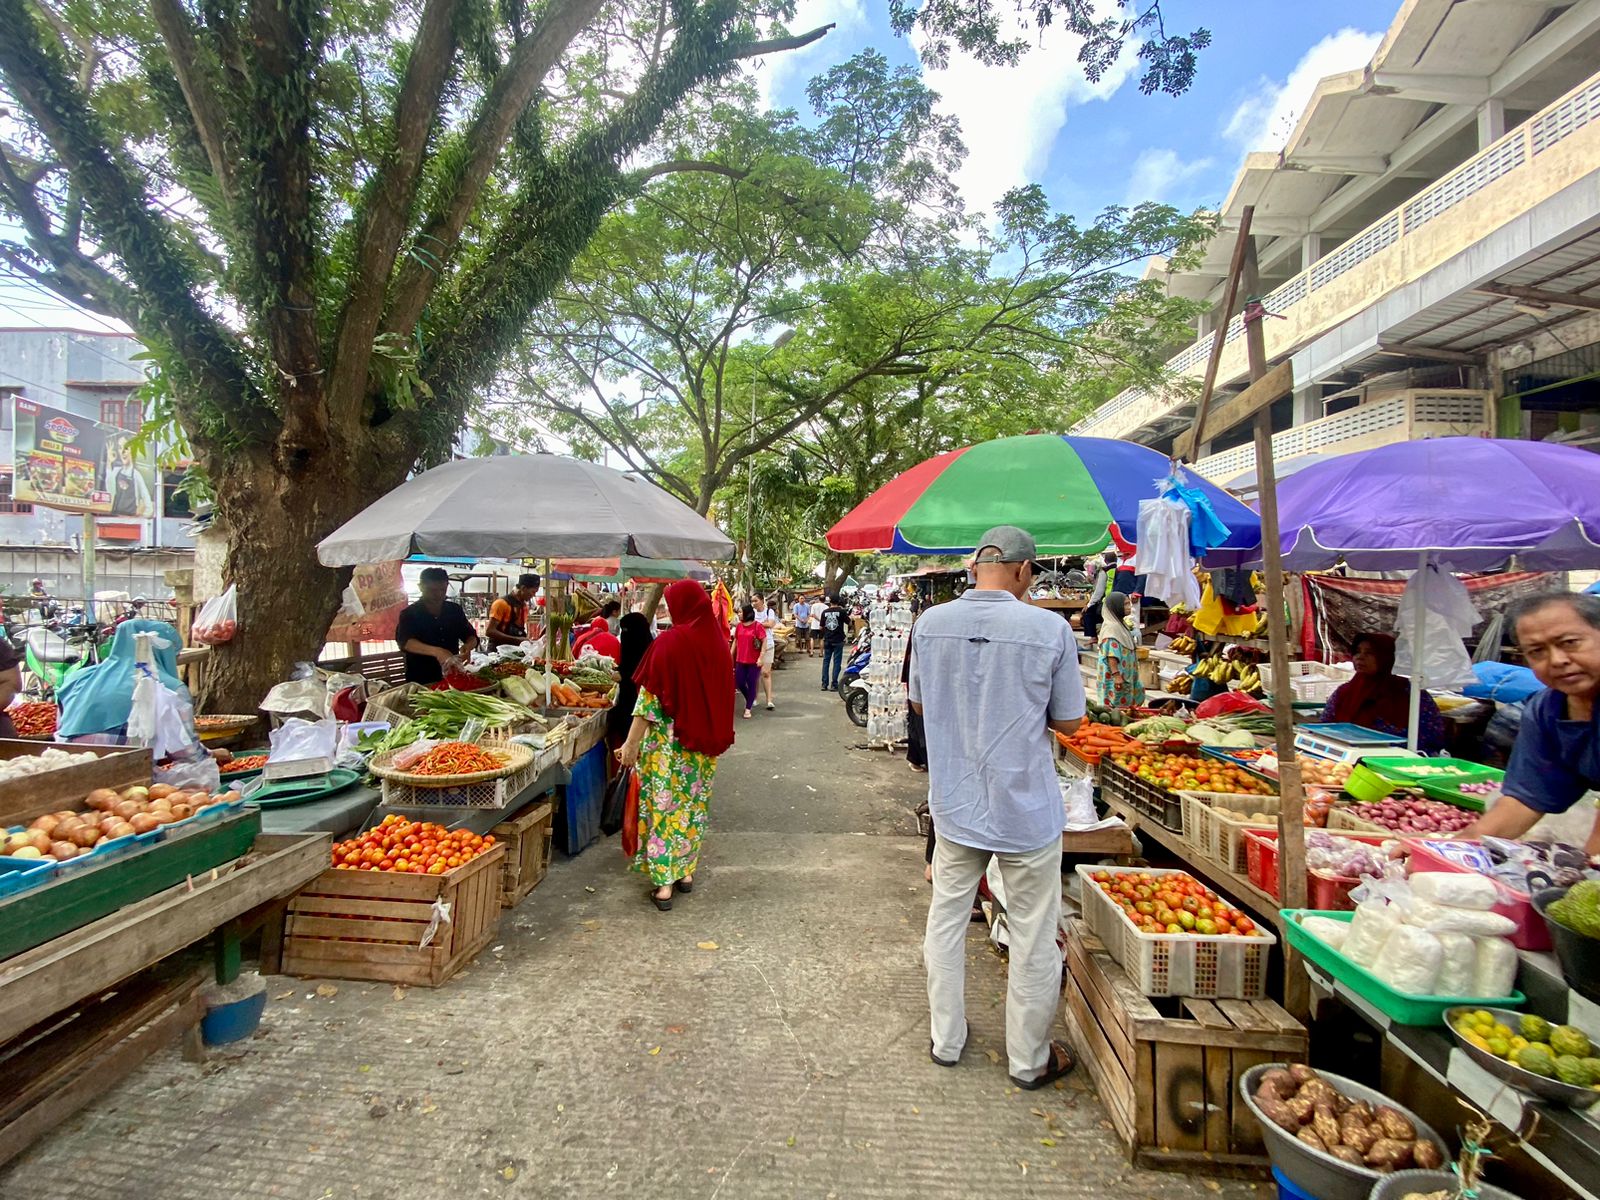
[1195,389,1493,483]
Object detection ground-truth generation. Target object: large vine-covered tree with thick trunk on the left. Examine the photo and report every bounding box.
[0,0,827,710]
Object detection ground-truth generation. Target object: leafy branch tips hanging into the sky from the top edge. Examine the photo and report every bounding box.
[890,0,1211,96]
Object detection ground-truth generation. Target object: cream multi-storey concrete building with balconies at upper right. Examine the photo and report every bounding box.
[1072,0,1600,482]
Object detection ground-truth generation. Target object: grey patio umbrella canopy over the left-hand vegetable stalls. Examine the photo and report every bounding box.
[317,454,733,566]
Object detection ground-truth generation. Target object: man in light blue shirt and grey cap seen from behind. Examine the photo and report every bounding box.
[910,525,1085,1090]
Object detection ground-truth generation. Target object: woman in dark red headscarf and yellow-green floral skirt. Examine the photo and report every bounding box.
[616,579,733,912]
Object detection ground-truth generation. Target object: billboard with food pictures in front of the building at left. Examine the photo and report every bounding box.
[11,397,158,517]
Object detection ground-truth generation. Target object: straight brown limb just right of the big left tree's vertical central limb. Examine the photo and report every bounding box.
[324,0,459,435]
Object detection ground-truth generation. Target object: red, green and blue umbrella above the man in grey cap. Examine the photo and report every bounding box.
[827,434,1261,565]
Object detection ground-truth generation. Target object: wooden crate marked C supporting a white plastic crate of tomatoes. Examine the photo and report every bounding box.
[1066,918,1307,1176]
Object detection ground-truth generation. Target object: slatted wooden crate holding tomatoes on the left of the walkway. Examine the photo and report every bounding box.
[283,843,506,987]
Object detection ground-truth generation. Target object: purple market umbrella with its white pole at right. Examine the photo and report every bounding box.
[1254,437,1600,750]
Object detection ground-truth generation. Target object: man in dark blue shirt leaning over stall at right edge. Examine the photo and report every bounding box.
[1464,592,1600,854]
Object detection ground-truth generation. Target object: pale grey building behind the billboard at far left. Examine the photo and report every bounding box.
[0,328,194,549]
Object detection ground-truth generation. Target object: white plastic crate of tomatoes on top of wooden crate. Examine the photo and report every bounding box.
[1077,866,1278,1000]
